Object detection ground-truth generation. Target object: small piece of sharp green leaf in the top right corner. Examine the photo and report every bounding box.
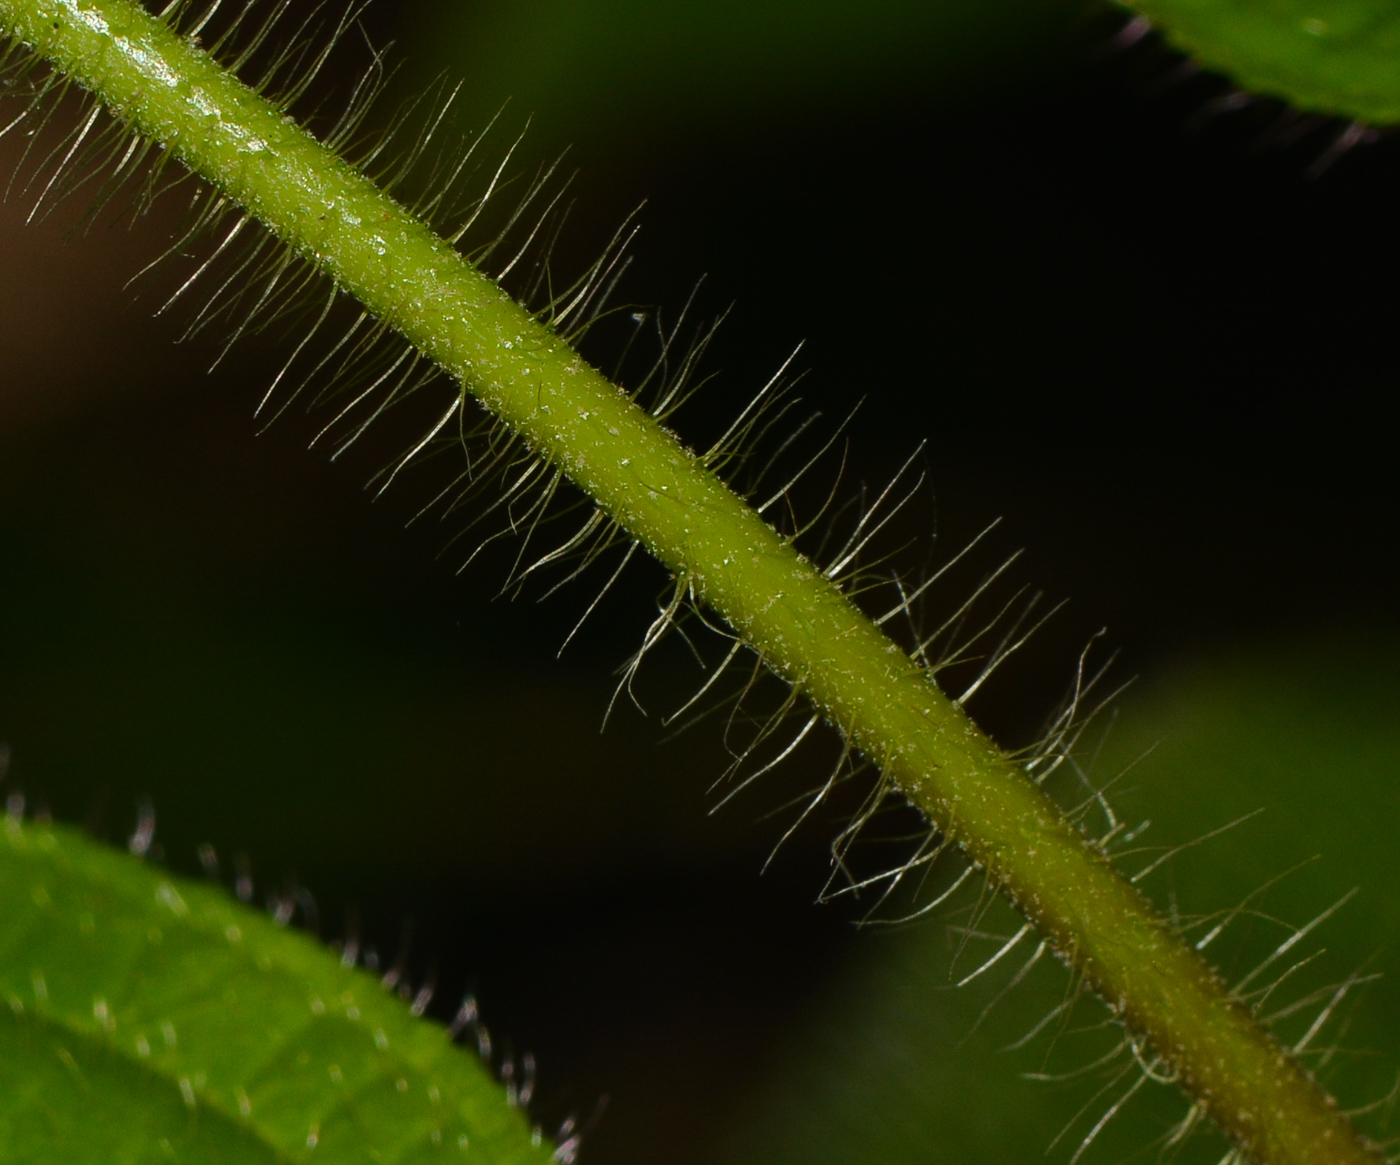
[1131,0,1400,126]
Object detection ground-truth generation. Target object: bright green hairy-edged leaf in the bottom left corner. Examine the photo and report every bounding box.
[0,815,553,1165]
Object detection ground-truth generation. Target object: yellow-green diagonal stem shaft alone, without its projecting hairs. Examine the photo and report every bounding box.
[0,0,1380,1165]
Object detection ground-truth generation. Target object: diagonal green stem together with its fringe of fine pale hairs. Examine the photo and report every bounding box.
[0,0,1394,1162]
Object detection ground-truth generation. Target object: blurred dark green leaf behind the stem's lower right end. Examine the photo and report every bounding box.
[720,639,1400,1165]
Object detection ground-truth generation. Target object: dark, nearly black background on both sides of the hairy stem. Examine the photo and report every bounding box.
[0,0,1400,1162]
